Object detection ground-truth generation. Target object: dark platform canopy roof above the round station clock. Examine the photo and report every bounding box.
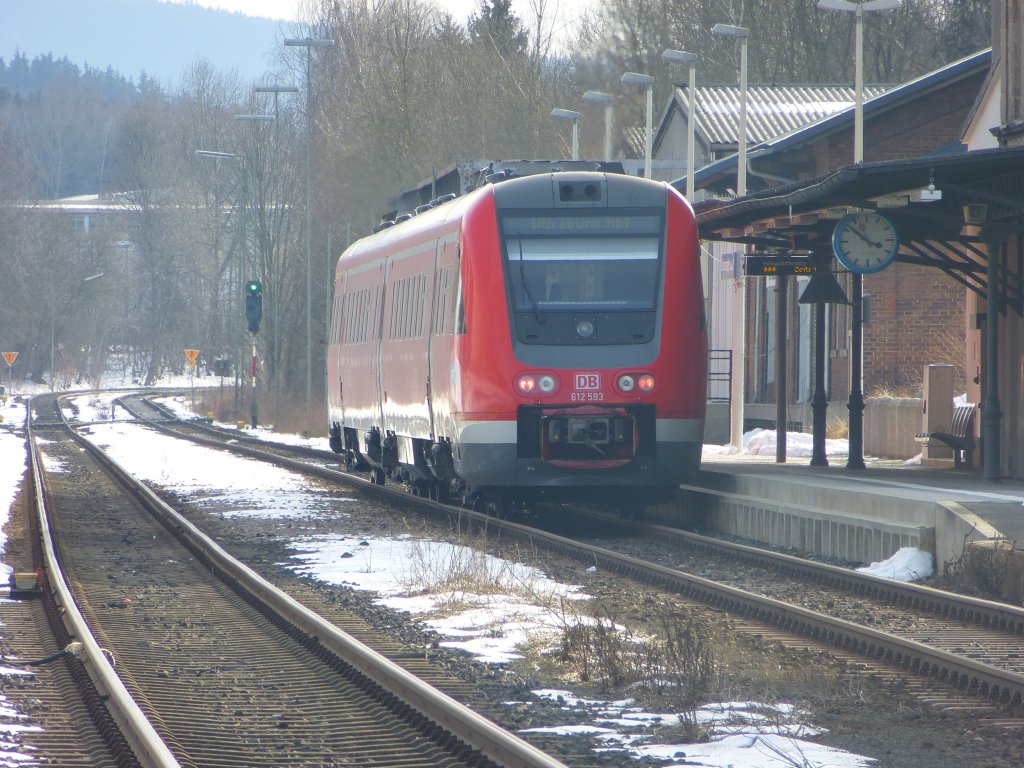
[694,146,1024,315]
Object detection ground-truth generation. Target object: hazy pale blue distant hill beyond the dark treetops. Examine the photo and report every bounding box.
[0,0,287,85]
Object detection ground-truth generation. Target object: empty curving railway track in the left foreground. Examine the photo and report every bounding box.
[14,398,577,768]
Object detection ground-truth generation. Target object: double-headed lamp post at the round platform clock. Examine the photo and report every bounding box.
[818,0,901,469]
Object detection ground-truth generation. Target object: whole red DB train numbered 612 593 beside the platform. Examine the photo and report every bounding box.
[328,172,708,512]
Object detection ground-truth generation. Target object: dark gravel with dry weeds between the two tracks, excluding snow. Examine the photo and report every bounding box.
[149,475,1024,768]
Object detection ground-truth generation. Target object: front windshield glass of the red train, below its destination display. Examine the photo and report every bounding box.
[504,216,662,312]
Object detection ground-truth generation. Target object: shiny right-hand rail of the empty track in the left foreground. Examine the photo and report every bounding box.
[58,399,567,768]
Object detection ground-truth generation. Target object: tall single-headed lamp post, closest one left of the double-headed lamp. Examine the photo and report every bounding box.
[711,24,751,450]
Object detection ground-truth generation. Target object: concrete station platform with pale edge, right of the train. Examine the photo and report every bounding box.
[648,452,1024,597]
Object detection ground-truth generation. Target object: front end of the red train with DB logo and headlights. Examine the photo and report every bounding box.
[460,173,707,501]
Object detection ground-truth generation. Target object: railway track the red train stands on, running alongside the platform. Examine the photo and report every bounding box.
[116,397,1024,727]
